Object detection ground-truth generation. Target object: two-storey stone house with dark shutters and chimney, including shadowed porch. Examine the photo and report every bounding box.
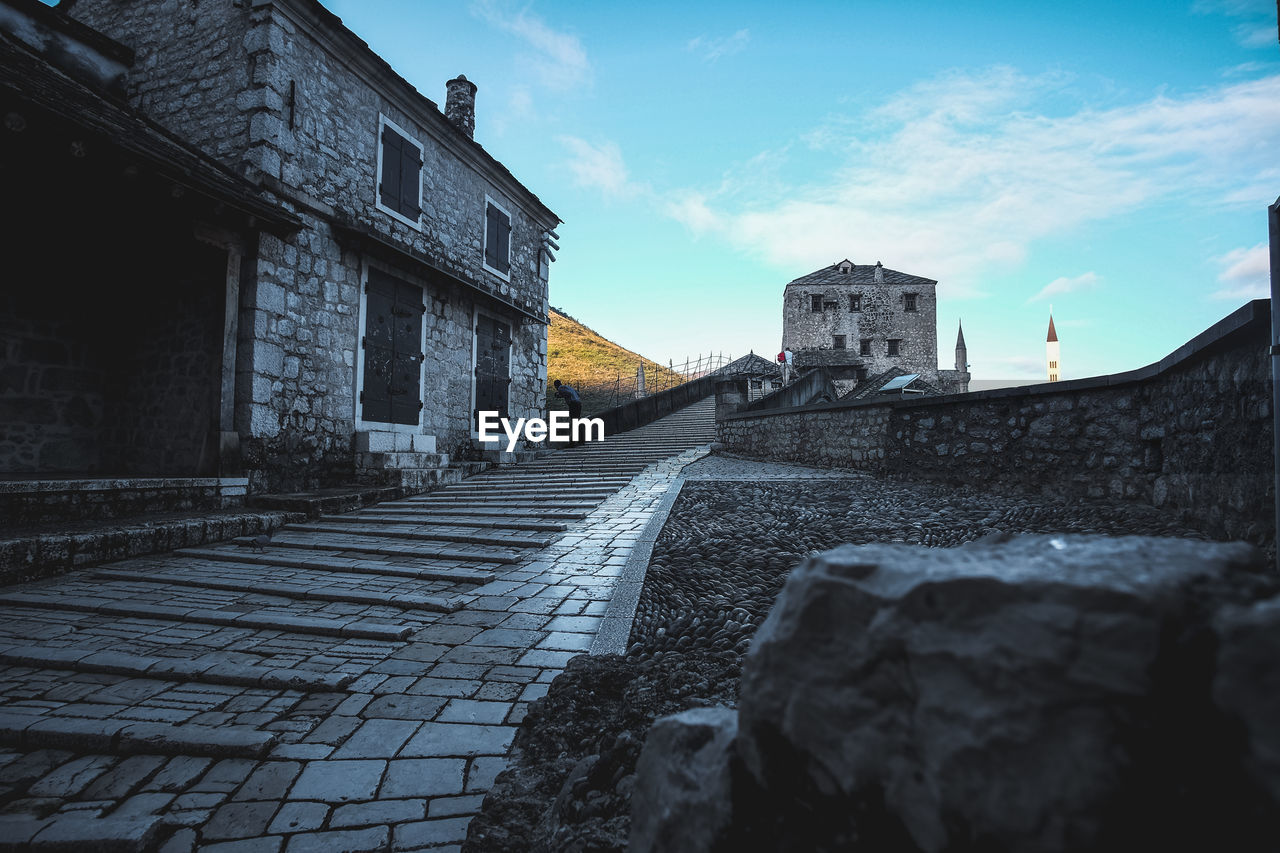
[0,0,559,491]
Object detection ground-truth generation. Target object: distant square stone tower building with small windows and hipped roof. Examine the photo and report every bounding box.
[782,259,969,393]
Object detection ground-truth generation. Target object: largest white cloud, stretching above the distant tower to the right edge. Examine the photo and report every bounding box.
[667,68,1280,295]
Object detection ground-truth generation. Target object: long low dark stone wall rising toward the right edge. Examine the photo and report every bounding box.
[717,300,1275,542]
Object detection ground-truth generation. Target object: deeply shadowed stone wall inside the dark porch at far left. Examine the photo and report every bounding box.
[0,233,227,476]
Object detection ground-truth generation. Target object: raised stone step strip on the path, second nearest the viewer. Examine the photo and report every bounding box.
[0,646,356,692]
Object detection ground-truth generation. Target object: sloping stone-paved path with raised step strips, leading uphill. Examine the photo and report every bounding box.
[0,400,714,853]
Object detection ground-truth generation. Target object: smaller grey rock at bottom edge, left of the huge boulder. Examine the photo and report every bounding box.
[627,708,737,853]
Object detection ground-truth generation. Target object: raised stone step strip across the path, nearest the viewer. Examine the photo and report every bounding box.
[0,713,279,758]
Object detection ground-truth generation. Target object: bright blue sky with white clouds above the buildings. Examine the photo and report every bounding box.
[325,0,1280,380]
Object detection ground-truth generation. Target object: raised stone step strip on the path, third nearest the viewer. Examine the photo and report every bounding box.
[0,593,413,642]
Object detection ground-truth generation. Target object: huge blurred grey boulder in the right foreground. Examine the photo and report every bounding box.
[736,535,1275,853]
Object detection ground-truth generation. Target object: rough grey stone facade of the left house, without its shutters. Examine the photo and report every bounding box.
[63,0,558,491]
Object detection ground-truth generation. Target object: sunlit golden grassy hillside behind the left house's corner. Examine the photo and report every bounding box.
[547,309,682,414]
